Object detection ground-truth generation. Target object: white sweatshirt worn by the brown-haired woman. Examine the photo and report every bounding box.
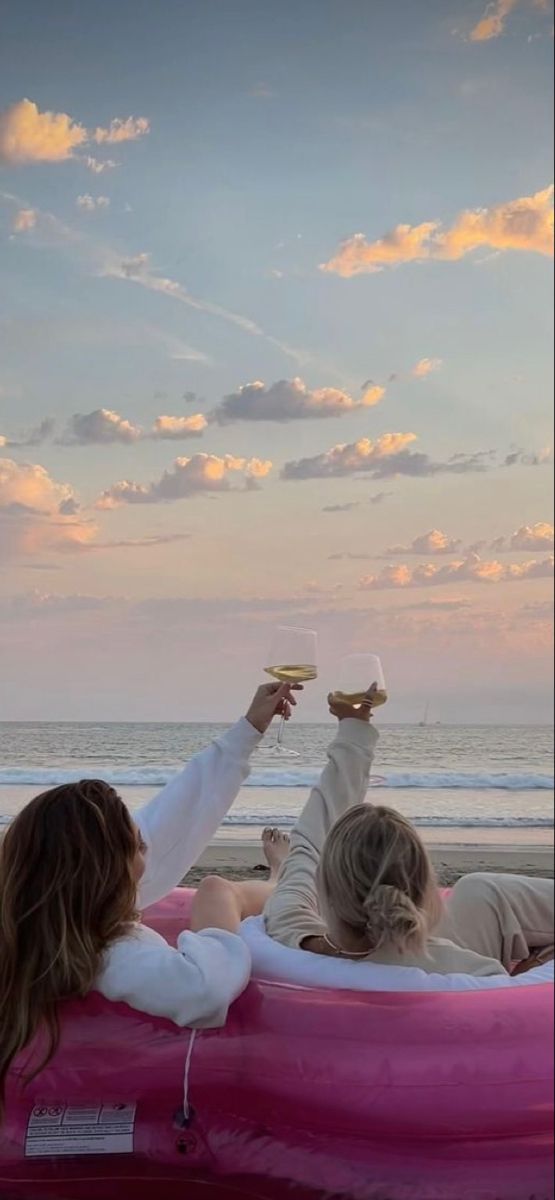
[95,718,261,1027]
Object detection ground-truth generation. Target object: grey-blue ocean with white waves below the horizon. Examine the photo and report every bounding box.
[0,721,554,845]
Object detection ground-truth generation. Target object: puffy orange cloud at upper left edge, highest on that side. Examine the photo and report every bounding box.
[0,100,149,169]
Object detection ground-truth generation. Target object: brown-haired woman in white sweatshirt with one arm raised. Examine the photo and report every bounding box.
[0,683,296,1115]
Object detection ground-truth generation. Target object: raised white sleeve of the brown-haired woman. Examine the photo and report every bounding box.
[135,718,261,908]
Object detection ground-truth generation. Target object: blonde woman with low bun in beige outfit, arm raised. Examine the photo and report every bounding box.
[264,689,554,976]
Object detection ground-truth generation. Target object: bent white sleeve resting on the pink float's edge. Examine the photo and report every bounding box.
[95,929,251,1028]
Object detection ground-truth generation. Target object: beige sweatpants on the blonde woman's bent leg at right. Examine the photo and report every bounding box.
[434,871,554,971]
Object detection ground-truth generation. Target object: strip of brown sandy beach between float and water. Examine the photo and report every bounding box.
[183,830,554,887]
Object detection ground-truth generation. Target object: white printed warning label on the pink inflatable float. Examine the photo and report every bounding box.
[25,1104,137,1158]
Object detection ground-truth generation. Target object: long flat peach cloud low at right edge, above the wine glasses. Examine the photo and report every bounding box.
[360,554,554,592]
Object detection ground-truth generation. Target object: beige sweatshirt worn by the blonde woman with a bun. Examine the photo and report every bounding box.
[264,719,507,976]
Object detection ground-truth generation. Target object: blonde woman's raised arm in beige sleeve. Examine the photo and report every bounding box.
[264,710,378,949]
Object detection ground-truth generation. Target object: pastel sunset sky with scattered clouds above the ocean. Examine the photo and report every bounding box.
[0,0,554,724]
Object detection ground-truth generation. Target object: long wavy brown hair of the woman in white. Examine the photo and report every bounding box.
[0,779,138,1120]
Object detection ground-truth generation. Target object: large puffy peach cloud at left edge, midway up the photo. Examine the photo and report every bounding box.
[0,458,96,559]
